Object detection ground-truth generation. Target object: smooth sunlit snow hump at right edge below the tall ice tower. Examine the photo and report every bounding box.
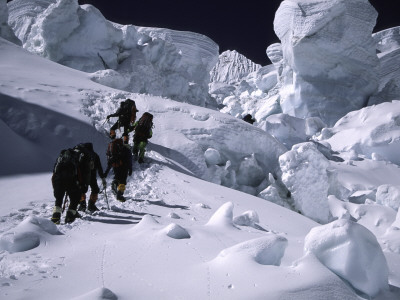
[318,101,400,164]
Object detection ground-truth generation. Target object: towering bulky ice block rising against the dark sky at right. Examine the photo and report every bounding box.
[274,0,379,126]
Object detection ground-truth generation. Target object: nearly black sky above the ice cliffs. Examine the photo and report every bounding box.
[7,0,400,65]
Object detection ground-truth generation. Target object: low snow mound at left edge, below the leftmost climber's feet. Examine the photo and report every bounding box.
[0,217,62,253]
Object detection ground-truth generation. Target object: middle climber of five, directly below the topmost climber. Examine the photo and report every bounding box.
[104,139,132,202]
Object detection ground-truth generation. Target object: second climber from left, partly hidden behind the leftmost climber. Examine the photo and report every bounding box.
[75,143,106,212]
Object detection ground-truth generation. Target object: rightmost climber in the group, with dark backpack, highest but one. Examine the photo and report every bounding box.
[130,112,154,163]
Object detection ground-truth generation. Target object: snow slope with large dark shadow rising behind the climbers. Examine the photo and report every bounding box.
[0,35,286,195]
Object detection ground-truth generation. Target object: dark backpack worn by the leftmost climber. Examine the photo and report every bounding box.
[53,148,78,183]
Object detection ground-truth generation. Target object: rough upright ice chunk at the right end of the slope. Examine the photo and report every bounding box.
[279,142,334,223]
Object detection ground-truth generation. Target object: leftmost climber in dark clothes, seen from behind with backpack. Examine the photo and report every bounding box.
[51,144,91,224]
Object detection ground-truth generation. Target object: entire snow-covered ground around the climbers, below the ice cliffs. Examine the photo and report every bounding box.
[0,2,400,300]
